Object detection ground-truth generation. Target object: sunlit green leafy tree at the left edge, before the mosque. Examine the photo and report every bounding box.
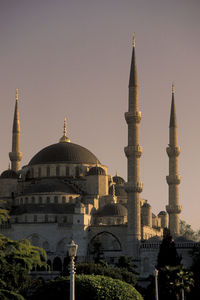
[0,234,46,292]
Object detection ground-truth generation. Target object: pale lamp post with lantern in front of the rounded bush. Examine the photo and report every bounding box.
[67,240,78,300]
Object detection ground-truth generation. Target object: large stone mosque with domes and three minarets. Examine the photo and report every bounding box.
[0,39,194,277]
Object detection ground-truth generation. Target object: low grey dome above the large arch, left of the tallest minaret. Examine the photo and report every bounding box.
[96,203,127,217]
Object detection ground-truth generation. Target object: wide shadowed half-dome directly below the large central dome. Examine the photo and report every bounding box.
[24,179,77,194]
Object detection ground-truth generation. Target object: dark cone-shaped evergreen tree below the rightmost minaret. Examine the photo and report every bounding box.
[157,228,181,270]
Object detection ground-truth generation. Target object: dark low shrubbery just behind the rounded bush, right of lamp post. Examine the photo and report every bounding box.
[76,263,137,286]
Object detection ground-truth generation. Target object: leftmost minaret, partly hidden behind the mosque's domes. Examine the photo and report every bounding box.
[9,89,22,171]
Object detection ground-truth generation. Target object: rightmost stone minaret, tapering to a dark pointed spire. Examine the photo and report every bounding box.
[166,85,182,237]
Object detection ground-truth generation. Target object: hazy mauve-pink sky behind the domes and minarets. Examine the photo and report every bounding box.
[0,0,200,229]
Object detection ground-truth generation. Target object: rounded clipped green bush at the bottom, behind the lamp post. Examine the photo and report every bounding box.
[27,275,143,300]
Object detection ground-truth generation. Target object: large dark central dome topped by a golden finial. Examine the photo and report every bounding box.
[29,143,100,165]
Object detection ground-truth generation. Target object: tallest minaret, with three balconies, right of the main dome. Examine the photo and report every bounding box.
[124,36,143,258]
